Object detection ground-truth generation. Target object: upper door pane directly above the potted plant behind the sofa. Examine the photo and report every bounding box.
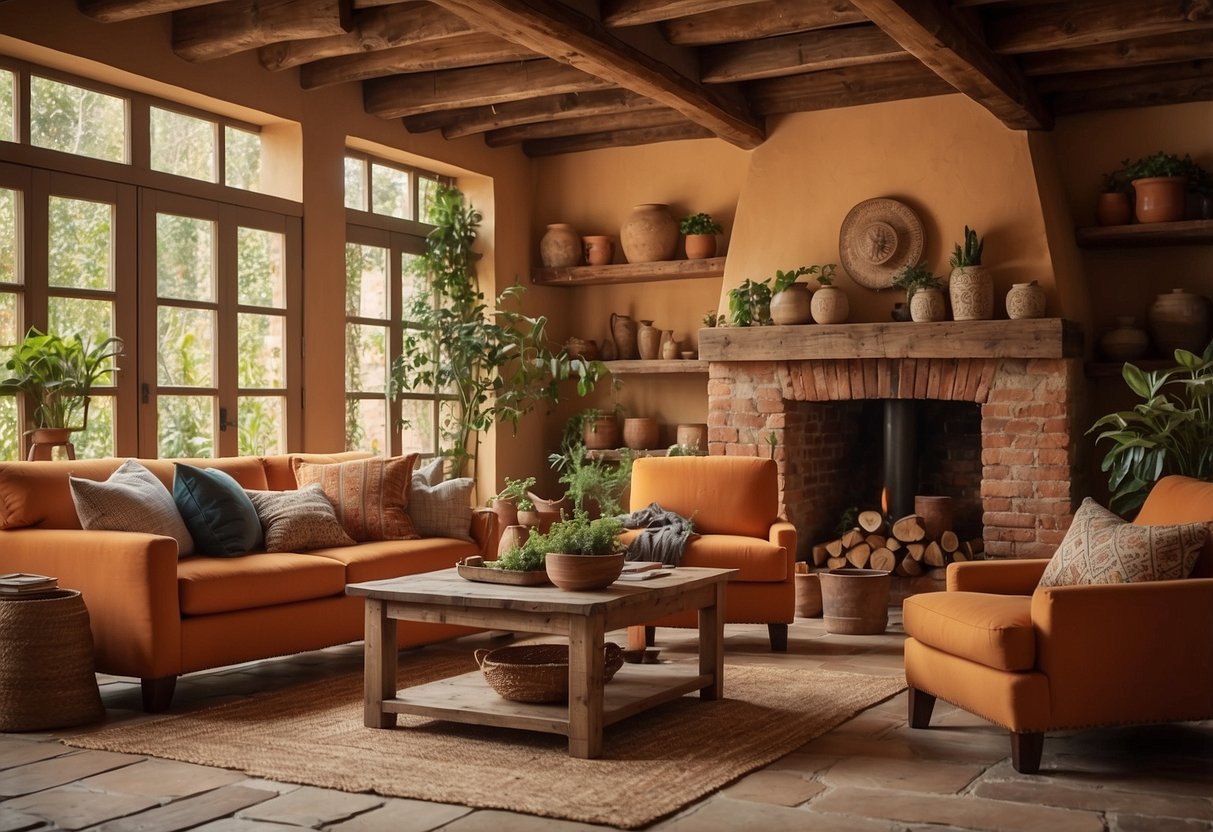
[46,196,114,290]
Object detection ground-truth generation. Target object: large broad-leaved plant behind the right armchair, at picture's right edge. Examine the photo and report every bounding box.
[1088,342,1213,514]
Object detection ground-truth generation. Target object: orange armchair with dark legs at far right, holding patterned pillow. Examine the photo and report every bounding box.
[902,477,1213,773]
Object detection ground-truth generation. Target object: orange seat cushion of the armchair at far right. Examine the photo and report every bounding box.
[901,592,1036,671]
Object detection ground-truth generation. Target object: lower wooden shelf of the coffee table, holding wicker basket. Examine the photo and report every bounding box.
[382,662,713,736]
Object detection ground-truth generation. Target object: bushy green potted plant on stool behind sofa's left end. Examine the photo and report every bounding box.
[0,327,123,443]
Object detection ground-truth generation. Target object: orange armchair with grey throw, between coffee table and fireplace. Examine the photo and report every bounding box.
[623,456,796,651]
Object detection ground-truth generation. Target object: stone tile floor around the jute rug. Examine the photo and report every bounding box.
[0,608,1213,832]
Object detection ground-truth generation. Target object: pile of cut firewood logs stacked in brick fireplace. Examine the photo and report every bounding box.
[813,511,985,577]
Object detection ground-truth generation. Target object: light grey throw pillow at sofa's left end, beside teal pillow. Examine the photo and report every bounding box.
[68,460,194,558]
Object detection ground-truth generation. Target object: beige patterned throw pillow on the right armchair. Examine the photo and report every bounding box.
[1040,497,1209,587]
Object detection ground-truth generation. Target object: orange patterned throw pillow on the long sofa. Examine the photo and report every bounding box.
[295,454,417,542]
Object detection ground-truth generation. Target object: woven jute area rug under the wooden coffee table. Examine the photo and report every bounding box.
[66,651,905,828]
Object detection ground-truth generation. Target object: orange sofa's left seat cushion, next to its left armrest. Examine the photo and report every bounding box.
[177,552,346,615]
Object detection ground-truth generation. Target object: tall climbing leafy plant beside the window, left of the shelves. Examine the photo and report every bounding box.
[392,186,607,473]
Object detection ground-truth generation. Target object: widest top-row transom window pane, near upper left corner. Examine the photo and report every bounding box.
[29,75,127,163]
